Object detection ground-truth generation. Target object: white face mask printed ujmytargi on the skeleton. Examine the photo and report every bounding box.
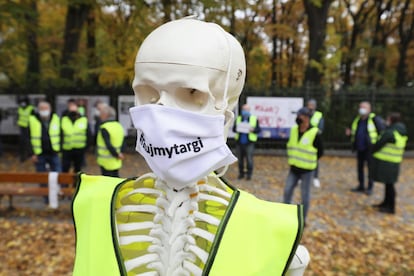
[129,104,237,189]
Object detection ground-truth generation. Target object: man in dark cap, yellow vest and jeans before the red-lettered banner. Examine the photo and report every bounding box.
[283,107,323,224]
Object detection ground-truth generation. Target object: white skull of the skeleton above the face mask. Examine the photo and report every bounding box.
[132,18,246,121]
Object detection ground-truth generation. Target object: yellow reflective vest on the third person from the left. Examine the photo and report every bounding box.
[62,116,88,150]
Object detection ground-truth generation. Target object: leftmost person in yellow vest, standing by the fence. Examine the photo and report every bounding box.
[17,96,34,162]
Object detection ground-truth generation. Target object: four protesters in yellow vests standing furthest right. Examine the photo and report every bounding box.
[283,99,408,223]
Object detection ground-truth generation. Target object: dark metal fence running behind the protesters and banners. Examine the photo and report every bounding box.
[1,88,414,150]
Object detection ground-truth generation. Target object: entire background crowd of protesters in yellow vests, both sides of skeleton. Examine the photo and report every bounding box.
[12,97,407,213]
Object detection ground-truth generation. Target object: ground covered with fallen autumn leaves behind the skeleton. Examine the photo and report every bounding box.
[0,154,414,275]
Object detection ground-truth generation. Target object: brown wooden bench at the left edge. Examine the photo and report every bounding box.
[0,172,76,209]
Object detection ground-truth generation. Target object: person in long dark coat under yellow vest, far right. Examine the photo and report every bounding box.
[370,112,408,214]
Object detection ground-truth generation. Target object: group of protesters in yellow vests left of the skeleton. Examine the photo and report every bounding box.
[17,97,124,189]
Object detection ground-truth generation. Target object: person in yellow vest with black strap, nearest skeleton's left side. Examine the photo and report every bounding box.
[96,104,124,177]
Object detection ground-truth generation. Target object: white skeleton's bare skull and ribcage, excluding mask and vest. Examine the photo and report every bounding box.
[116,18,307,275]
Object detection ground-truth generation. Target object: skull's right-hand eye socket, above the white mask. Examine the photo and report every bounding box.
[174,88,209,111]
